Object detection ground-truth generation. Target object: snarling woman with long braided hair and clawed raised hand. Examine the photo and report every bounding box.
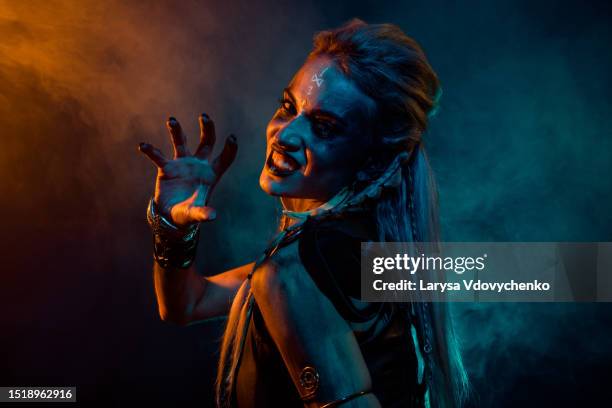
[140,20,466,408]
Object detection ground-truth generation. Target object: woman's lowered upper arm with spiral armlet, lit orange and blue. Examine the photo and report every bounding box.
[251,243,380,408]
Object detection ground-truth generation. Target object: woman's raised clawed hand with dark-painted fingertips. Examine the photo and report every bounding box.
[138,113,238,226]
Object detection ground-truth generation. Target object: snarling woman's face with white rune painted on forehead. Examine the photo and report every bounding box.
[259,57,375,202]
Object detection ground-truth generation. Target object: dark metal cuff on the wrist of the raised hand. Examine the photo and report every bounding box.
[147,198,200,268]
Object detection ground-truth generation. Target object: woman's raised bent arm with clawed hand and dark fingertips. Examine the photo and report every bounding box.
[139,114,252,325]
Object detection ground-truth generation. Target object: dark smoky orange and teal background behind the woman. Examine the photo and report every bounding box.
[0,0,612,407]
